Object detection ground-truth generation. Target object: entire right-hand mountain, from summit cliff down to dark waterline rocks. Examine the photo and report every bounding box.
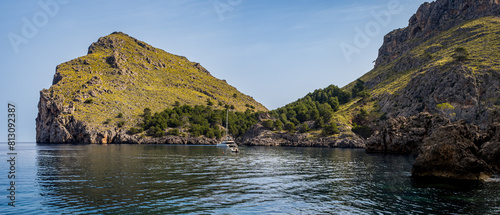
[356,0,500,179]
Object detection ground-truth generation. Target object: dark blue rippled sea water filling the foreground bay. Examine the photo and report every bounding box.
[0,143,500,214]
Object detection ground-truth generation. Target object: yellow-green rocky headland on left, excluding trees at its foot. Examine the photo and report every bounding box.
[36,32,267,143]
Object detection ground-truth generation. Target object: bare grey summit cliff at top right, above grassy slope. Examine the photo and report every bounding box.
[375,0,500,66]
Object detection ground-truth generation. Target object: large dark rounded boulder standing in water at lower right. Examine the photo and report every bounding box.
[412,121,492,180]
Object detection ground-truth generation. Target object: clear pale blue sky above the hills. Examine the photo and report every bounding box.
[0,0,425,142]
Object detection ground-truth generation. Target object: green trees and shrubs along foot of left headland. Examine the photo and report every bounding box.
[135,105,264,139]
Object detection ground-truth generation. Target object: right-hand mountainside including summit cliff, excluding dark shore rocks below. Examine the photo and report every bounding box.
[352,0,500,129]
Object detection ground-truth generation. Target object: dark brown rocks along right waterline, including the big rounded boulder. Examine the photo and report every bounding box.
[366,113,500,180]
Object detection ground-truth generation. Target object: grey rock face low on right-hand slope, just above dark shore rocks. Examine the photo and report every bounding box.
[379,64,500,129]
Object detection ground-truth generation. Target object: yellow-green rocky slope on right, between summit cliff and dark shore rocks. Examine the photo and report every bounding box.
[352,16,500,129]
